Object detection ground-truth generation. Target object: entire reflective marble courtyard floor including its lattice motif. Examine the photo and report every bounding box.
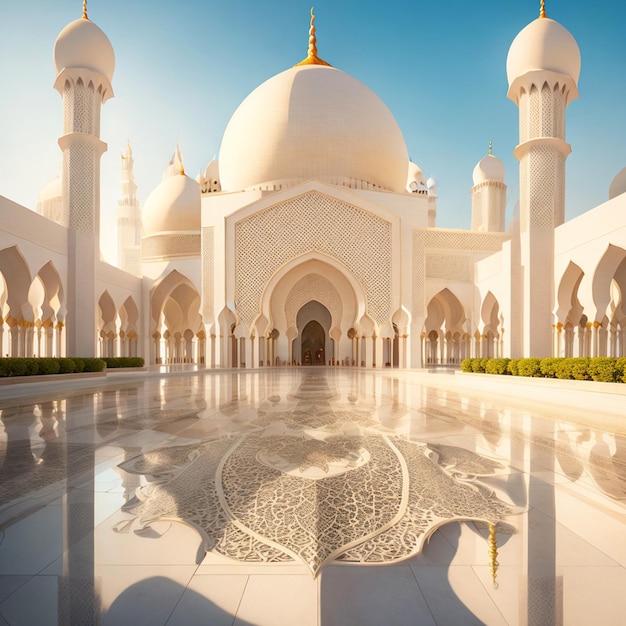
[0,367,626,626]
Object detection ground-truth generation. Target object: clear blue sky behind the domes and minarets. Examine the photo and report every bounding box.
[0,0,626,260]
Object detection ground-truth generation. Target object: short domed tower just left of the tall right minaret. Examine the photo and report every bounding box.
[470,141,506,233]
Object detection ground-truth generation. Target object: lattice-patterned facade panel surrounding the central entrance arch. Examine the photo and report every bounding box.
[235,192,391,325]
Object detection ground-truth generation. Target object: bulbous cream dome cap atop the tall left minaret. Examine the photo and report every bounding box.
[54,18,115,82]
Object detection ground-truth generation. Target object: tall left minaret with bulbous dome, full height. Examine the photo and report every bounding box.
[54,1,115,356]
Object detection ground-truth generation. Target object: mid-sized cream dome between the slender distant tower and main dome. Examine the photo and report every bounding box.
[142,174,200,236]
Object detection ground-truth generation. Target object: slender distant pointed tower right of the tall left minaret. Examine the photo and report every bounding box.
[117,141,141,276]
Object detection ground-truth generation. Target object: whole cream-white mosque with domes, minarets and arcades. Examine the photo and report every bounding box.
[0,3,626,368]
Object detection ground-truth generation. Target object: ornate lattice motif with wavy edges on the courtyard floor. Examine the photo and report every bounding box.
[117,370,514,576]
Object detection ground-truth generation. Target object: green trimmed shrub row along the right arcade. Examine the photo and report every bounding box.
[461,356,626,383]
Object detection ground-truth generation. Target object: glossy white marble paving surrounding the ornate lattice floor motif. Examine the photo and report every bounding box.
[0,368,626,626]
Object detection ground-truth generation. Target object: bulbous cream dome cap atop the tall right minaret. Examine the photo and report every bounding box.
[506,17,580,86]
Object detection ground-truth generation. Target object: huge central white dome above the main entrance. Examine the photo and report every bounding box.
[219,65,409,192]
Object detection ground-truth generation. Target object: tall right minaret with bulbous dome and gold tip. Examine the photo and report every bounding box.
[506,1,580,357]
